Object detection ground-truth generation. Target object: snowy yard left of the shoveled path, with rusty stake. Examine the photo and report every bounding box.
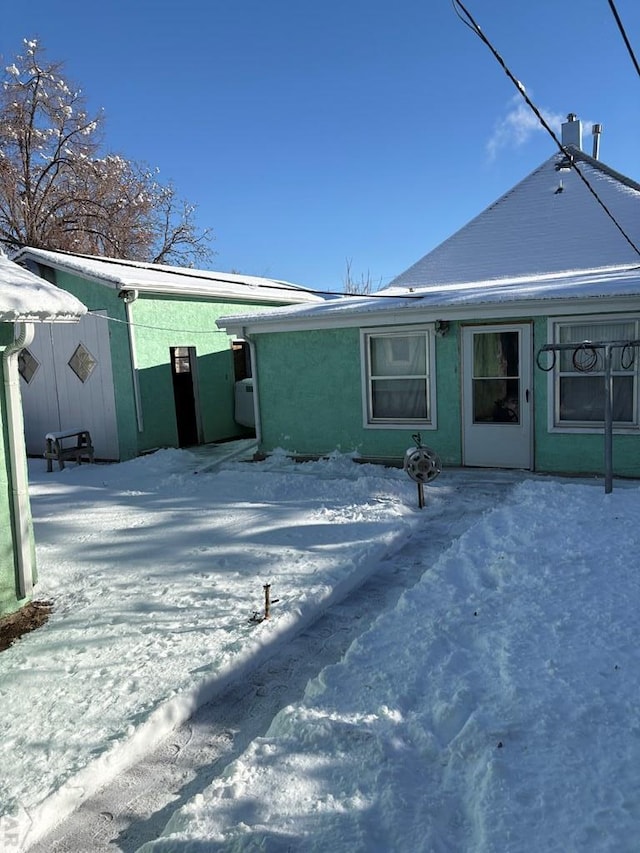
[0,442,438,853]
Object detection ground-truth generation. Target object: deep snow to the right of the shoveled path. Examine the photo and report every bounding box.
[143,466,640,853]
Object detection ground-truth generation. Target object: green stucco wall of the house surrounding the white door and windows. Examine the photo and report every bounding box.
[254,317,640,477]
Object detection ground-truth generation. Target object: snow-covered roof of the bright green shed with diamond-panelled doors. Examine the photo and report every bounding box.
[16,247,322,304]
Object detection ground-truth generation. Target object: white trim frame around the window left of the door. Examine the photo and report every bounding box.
[360,323,438,430]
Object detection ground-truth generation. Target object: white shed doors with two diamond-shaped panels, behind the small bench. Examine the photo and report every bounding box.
[20,312,119,459]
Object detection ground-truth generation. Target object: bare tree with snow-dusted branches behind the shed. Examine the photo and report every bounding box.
[0,40,213,265]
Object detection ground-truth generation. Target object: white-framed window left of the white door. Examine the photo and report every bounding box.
[362,328,433,426]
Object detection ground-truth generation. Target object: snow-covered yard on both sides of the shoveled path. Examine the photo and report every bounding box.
[0,451,640,853]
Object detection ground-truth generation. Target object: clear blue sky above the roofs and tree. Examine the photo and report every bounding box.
[0,0,640,290]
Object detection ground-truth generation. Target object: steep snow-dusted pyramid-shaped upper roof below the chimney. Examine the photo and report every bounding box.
[389,148,640,290]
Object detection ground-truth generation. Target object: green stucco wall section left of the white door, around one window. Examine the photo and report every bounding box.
[256,328,461,465]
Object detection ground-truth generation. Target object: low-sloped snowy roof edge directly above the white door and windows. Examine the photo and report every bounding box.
[217,259,640,333]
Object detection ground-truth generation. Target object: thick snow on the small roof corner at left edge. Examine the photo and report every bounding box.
[0,252,87,323]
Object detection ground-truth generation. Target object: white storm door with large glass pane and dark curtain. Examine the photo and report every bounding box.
[462,324,533,468]
